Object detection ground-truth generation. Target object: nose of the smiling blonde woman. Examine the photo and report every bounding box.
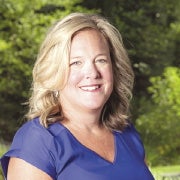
[84,63,101,79]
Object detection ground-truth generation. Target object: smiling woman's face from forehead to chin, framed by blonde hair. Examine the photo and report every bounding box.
[60,30,113,112]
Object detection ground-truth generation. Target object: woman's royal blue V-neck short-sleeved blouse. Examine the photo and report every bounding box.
[0,118,154,180]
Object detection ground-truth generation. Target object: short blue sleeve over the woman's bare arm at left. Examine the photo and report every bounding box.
[0,119,56,179]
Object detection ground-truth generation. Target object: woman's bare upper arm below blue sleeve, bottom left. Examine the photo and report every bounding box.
[7,157,53,180]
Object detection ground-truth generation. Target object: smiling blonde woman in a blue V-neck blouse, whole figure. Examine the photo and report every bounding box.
[1,13,153,180]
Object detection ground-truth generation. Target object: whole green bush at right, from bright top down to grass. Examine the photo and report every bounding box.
[137,67,180,165]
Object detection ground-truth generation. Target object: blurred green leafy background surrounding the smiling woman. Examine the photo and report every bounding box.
[0,0,180,177]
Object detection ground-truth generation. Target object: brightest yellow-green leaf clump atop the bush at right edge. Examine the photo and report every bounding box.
[149,67,180,112]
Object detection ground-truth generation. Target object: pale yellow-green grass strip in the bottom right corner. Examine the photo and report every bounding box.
[150,165,180,180]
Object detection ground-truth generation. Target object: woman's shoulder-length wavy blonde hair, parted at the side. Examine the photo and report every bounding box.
[26,13,134,130]
